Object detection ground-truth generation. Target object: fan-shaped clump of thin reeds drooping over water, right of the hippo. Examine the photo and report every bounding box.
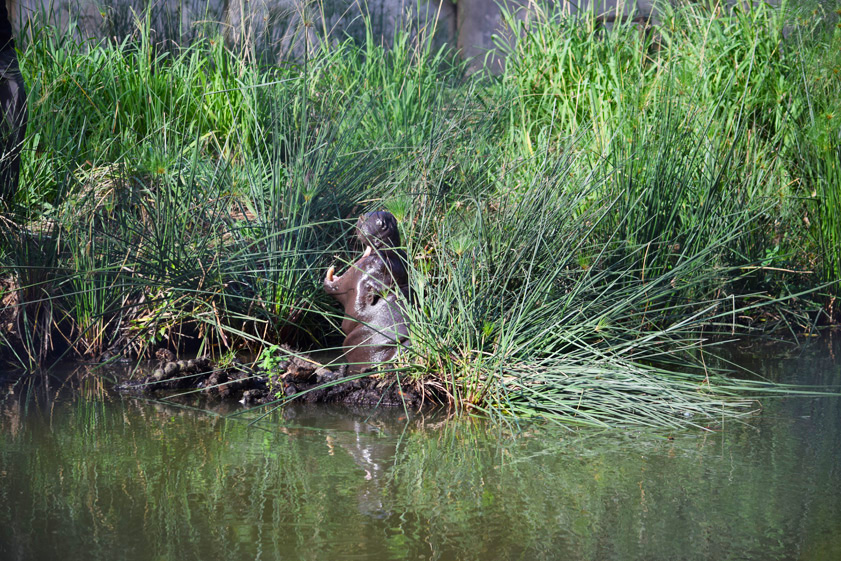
[392,107,768,425]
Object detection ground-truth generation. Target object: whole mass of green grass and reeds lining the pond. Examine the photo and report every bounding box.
[0,3,841,426]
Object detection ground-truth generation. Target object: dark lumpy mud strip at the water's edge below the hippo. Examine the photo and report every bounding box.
[116,356,443,409]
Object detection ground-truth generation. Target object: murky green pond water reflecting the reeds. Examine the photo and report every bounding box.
[0,338,841,561]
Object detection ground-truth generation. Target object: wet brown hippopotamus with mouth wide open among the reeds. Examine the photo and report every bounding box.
[324,211,409,372]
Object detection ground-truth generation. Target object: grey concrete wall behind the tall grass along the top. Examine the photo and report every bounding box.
[7,0,654,69]
